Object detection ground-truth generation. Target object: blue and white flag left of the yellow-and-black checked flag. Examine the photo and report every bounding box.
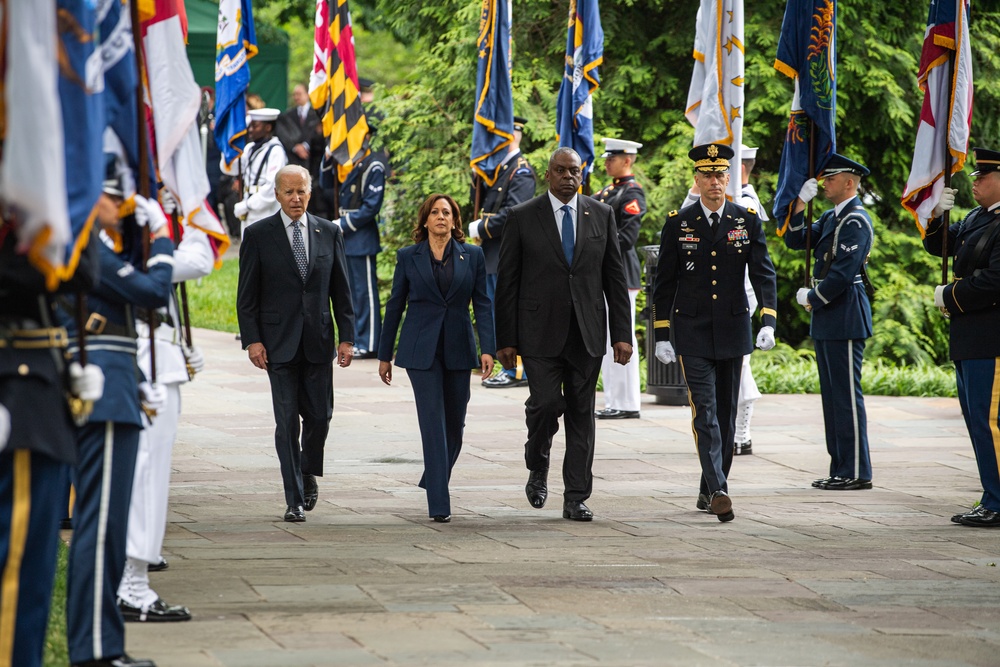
[215,0,257,170]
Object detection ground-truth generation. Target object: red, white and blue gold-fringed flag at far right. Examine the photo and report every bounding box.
[903,0,972,237]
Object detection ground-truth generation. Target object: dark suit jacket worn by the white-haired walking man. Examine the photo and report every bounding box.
[236,213,354,364]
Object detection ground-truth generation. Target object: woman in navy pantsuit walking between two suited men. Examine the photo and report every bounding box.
[378,194,496,523]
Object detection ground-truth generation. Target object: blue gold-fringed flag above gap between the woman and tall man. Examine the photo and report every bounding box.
[469,0,514,186]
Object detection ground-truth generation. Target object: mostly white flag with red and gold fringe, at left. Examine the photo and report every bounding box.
[142,0,229,263]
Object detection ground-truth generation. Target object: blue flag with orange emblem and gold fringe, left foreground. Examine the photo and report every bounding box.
[56,0,107,276]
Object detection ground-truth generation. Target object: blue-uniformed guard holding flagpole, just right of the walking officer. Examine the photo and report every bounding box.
[784,154,874,491]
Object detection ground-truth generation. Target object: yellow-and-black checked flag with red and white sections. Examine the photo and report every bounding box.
[309,0,369,183]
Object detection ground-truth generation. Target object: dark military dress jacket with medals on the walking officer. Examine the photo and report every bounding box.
[653,202,777,359]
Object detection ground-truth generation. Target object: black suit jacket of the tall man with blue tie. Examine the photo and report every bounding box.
[494,192,632,357]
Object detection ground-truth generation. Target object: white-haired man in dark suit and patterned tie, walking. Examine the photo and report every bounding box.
[236,165,354,522]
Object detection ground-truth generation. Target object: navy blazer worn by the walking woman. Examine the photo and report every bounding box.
[378,240,496,370]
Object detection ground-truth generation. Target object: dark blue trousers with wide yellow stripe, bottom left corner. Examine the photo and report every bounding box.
[0,449,67,667]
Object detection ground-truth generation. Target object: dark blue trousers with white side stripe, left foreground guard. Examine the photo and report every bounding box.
[66,422,142,664]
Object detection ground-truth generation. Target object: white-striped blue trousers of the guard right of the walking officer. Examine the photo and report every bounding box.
[815,339,872,479]
